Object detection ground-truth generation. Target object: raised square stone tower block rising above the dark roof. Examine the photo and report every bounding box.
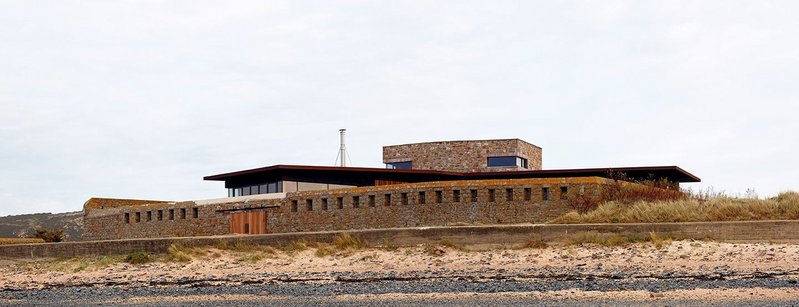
[383,139,542,172]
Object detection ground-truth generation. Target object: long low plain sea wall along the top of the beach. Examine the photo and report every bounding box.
[6,221,799,258]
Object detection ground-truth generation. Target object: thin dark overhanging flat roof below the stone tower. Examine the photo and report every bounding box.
[203,164,701,182]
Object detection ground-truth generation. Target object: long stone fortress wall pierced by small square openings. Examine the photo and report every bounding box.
[84,177,610,240]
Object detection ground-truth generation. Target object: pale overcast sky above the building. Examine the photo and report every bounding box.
[0,0,799,215]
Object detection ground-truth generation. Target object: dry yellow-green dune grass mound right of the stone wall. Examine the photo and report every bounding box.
[550,191,799,224]
